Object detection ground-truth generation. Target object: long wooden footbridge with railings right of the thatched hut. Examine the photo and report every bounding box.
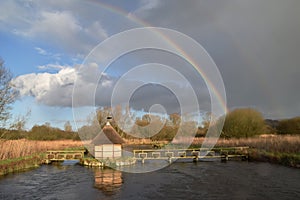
[133,147,249,163]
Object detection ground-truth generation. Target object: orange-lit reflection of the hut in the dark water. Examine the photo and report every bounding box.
[94,169,123,195]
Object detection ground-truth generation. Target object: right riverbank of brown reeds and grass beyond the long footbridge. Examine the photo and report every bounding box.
[192,135,300,168]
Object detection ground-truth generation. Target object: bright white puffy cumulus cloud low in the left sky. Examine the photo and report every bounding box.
[13,64,113,107]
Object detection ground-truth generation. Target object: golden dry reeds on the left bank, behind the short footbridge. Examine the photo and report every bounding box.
[0,139,83,160]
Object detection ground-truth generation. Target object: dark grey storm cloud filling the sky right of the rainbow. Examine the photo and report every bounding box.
[132,0,300,118]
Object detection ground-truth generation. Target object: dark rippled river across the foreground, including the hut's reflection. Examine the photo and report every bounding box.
[0,161,300,200]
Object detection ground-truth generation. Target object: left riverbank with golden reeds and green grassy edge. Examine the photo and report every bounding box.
[0,139,82,175]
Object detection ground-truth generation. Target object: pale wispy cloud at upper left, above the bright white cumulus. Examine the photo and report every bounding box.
[17,11,107,55]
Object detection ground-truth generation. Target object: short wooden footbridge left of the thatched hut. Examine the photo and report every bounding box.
[45,150,85,164]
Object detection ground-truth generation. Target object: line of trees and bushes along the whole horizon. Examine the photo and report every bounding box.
[0,108,300,141]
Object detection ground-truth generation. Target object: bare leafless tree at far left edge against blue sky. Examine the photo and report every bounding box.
[0,58,18,127]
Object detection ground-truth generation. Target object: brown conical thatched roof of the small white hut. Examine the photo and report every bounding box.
[91,123,125,145]
